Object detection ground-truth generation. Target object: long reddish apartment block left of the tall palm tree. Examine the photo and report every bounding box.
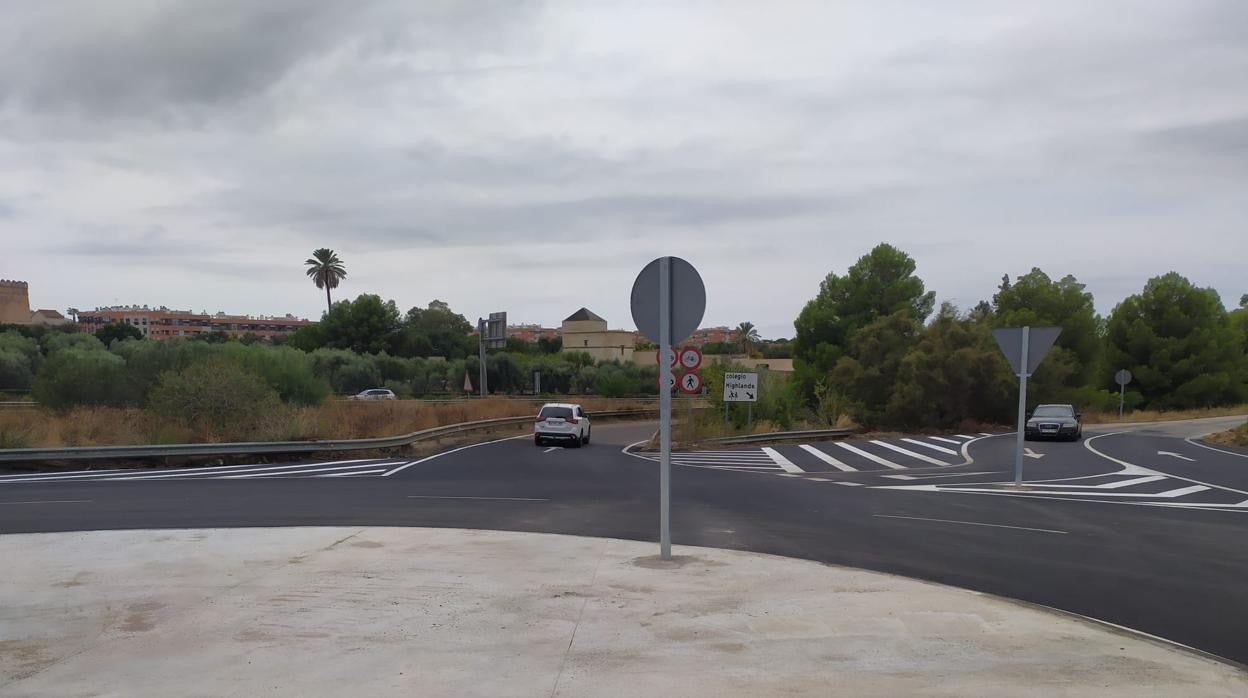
[79,306,308,341]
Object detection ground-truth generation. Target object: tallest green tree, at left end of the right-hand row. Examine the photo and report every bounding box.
[792,245,936,401]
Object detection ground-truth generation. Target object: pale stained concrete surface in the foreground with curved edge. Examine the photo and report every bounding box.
[0,527,1248,698]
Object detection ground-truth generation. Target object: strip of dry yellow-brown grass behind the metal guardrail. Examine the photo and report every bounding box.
[0,398,653,448]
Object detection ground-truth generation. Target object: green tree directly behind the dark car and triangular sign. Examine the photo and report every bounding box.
[991,268,1101,402]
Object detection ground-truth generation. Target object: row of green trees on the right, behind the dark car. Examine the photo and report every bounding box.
[791,245,1248,428]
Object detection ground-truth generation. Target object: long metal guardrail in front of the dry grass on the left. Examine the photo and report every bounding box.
[0,410,655,462]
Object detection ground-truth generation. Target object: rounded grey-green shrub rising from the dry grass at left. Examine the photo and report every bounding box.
[150,358,282,441]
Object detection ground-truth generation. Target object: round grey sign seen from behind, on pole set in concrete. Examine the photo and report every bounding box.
[630,257,706,559]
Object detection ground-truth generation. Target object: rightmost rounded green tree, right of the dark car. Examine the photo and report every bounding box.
[1104,272,1248,410]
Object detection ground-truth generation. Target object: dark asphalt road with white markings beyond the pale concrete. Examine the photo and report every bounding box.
[0,422,1248,663]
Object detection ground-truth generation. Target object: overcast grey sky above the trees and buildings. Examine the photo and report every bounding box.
[0,0,1248,337]
